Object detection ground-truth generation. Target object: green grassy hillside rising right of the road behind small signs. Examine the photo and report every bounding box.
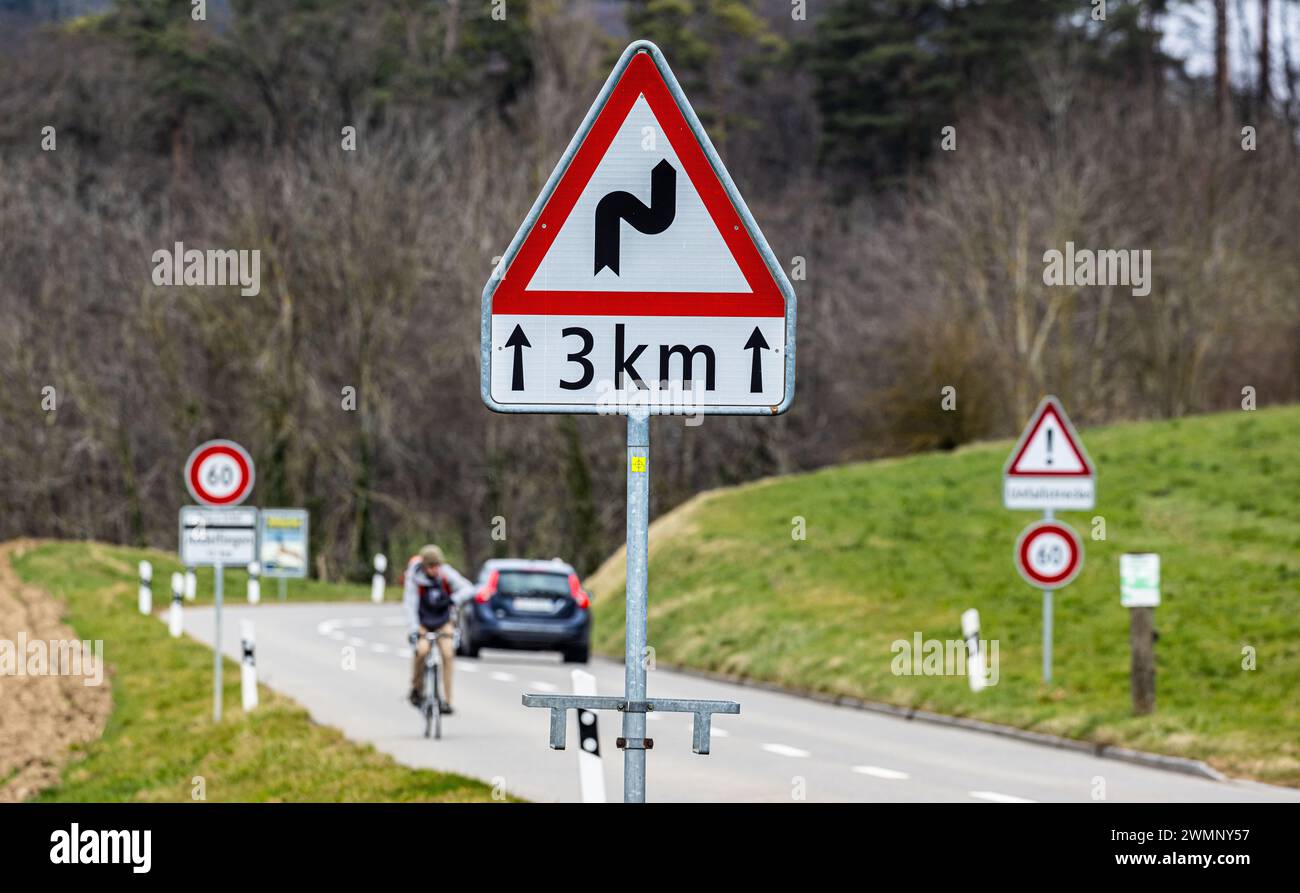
[588,407,1300,785]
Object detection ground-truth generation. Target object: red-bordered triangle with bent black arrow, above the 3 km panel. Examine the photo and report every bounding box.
[490,44,788,317]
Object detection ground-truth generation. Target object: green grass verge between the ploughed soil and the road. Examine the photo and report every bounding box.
[14,542,504,802]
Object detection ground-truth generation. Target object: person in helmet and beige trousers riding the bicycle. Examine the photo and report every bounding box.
[402,545,475,714]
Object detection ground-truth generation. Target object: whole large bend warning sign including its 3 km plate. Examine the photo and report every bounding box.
[482,51,794,413]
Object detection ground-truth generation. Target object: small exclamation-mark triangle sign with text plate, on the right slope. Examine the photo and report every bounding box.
[1002,396,1097,510]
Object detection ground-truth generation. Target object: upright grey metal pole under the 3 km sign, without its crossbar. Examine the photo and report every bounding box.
[623,407,650,803]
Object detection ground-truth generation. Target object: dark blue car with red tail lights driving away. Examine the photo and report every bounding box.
[460,558,592,663]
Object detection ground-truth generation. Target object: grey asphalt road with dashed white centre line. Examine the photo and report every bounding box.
[185,602,1300,802]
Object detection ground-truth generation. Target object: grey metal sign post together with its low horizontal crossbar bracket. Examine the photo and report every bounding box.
[523,408,740,803]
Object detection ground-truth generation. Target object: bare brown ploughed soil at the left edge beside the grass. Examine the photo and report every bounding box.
[0,541,112,803]
